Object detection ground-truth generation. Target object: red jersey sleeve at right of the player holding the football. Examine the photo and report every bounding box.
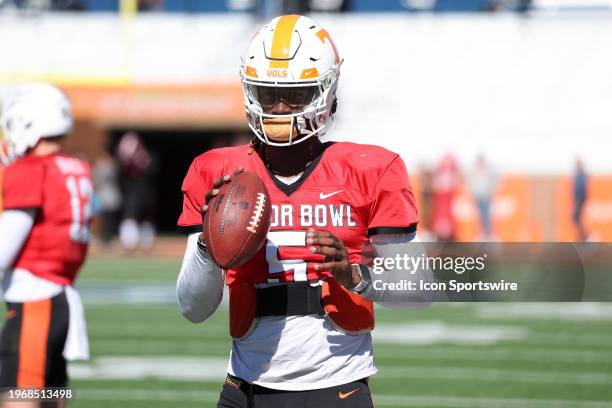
[368,156,419,235]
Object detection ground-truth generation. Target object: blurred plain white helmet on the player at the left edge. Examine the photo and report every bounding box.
[0,83,73,163]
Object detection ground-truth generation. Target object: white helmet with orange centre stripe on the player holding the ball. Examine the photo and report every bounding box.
[240,15,342,146]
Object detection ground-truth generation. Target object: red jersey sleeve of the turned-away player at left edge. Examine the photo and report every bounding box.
[2,162,45,210]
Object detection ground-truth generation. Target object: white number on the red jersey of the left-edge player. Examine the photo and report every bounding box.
[66,176,93,244]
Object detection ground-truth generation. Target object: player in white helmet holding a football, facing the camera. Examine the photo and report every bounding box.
[177,15,427,408]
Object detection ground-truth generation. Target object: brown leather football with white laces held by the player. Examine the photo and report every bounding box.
[203,171,271,269]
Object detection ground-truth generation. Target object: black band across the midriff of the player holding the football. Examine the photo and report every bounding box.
[255,282,325,317]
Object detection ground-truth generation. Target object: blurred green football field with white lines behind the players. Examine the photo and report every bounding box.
[37,257,612,408]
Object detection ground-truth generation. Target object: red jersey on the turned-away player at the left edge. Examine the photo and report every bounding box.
[2,154,93,285]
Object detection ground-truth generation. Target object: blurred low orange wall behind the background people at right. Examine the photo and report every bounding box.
[412,175,612,242]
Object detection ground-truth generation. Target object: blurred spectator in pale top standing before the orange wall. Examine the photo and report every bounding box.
[468,154,497,241]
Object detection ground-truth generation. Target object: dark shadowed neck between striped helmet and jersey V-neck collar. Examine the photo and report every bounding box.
[257,130,324,177]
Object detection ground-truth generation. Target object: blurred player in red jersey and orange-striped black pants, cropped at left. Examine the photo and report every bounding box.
[0,84,93,407]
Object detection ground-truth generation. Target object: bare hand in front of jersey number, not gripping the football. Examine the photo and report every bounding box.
[306,228,361,289]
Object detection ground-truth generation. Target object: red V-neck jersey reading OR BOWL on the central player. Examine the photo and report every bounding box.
[178,142,418,285]
